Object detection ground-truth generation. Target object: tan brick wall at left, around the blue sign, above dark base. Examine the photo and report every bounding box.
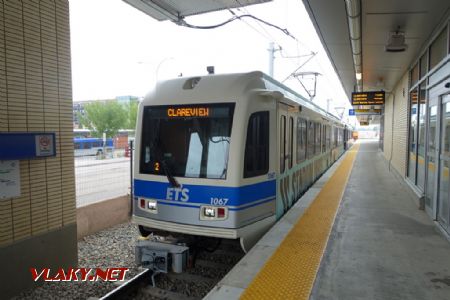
[0,0,76,247]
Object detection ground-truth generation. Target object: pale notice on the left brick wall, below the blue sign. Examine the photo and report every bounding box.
[0,160,20,200]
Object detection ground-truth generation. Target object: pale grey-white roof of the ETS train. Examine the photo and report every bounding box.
[143,71,342,123]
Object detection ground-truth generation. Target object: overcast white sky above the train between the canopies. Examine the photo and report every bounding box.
[69,0,356,122]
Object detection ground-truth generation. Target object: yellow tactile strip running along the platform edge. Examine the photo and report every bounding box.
[241,144,359,300]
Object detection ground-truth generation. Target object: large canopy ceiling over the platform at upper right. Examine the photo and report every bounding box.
[302,0,450,99]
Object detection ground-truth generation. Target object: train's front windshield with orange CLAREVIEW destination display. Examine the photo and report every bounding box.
[140,104,234,179]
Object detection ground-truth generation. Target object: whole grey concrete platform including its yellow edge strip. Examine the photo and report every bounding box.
[205,141,450,299]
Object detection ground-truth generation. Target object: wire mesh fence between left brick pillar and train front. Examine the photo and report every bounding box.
[75,144,132,207]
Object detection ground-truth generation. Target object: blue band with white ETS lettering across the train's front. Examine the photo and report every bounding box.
[134,179,276,206]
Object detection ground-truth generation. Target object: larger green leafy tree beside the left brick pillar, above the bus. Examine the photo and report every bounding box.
[78,101,128,138]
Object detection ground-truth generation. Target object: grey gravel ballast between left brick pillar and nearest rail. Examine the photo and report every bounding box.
[13,223,139,300]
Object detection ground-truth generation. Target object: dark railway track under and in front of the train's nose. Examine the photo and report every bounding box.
[100,240,244,300]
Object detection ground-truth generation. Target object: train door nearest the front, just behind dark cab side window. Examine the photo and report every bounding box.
[276,102,294,219]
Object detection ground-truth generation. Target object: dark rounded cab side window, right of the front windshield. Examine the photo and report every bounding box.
[244,111,269,178]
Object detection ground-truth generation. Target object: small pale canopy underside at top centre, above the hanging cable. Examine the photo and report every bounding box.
[123,0,272,22]
